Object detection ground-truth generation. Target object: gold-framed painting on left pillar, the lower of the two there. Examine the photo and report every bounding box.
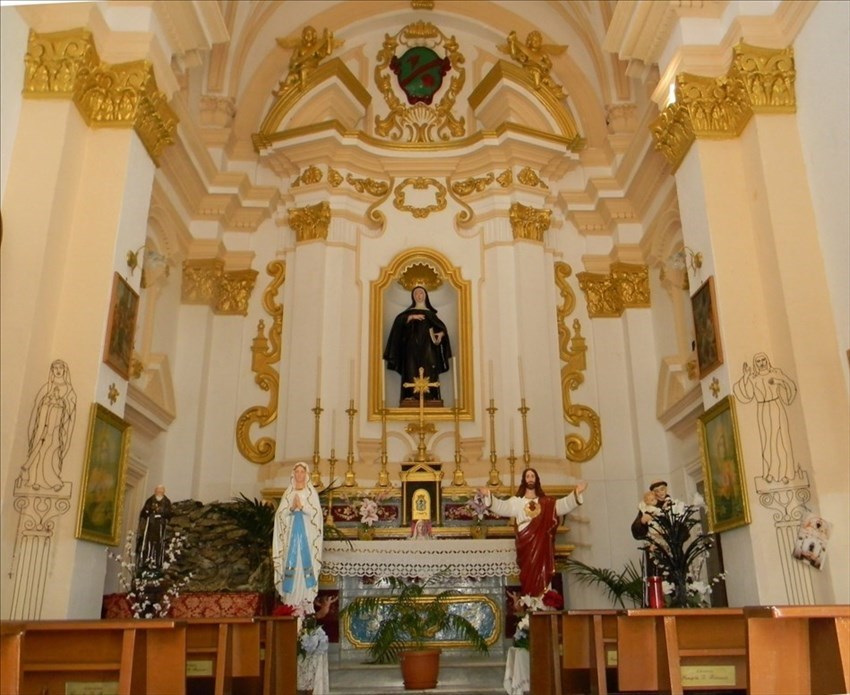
[76,403,132,546]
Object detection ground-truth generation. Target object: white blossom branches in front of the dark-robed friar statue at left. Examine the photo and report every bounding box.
[106,531,192,618]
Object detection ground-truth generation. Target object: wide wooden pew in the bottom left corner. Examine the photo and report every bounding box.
[4,620,186,695]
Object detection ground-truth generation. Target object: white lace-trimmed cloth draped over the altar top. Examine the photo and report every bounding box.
[322,538,519,579]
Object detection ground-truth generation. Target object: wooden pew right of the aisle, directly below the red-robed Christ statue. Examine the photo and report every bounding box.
[529,609,619,695]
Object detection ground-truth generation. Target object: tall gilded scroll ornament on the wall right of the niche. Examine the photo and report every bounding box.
[555,263,602,462]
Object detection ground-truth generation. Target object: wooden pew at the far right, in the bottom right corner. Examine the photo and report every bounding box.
[744,605,850,695]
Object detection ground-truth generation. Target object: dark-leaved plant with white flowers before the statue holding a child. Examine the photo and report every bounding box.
[644,498,725,608]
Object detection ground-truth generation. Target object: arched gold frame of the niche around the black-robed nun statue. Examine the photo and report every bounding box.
[368,247,475,420]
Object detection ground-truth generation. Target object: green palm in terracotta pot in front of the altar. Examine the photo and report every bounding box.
[340,572,488,690]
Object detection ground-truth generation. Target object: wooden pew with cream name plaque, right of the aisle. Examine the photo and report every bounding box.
[617,608,747,695]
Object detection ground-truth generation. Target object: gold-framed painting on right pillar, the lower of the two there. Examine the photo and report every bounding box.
[697,396,750,533]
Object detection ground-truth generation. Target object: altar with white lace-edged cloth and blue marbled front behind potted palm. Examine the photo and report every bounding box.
[322,538,519,659]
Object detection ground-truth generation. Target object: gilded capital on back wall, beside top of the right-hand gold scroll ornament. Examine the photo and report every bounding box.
[576,263,650,318]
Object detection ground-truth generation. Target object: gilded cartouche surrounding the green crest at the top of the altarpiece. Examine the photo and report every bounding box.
[374,21,466,144]
